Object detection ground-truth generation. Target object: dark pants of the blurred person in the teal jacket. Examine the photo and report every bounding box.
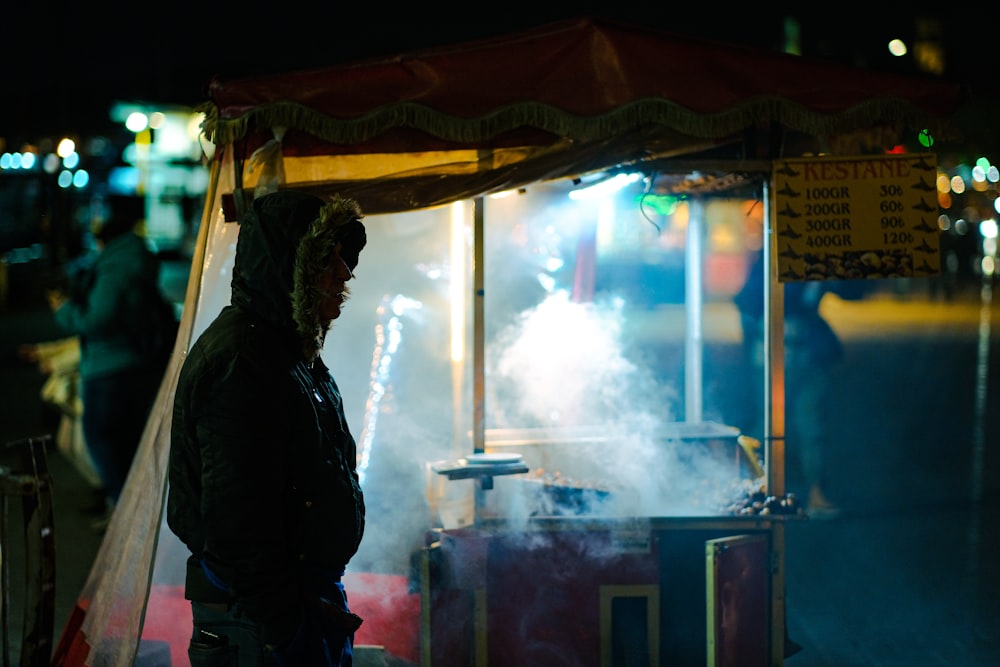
[82,369,160,503]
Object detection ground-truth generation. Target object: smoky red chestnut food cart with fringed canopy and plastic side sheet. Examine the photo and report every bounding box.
[57,20,957,666]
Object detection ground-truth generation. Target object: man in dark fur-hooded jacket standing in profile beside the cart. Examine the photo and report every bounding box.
[167,191,366,667]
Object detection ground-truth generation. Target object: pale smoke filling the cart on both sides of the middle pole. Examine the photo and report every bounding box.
[332,209,752,573]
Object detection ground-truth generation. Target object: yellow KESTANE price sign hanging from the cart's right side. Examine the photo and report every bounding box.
[772,153,941,282]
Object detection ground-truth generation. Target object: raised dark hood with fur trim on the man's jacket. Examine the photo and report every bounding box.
[232,190,367,360]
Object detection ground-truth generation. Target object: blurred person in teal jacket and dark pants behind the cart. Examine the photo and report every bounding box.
[48,197,172,530]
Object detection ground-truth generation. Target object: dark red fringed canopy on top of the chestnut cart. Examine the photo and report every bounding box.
[203,19,963,213]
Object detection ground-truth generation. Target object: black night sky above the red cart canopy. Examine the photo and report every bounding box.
[0,0,1000,145]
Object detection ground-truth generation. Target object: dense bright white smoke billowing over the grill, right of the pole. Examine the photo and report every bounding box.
[487,292,752,519]
